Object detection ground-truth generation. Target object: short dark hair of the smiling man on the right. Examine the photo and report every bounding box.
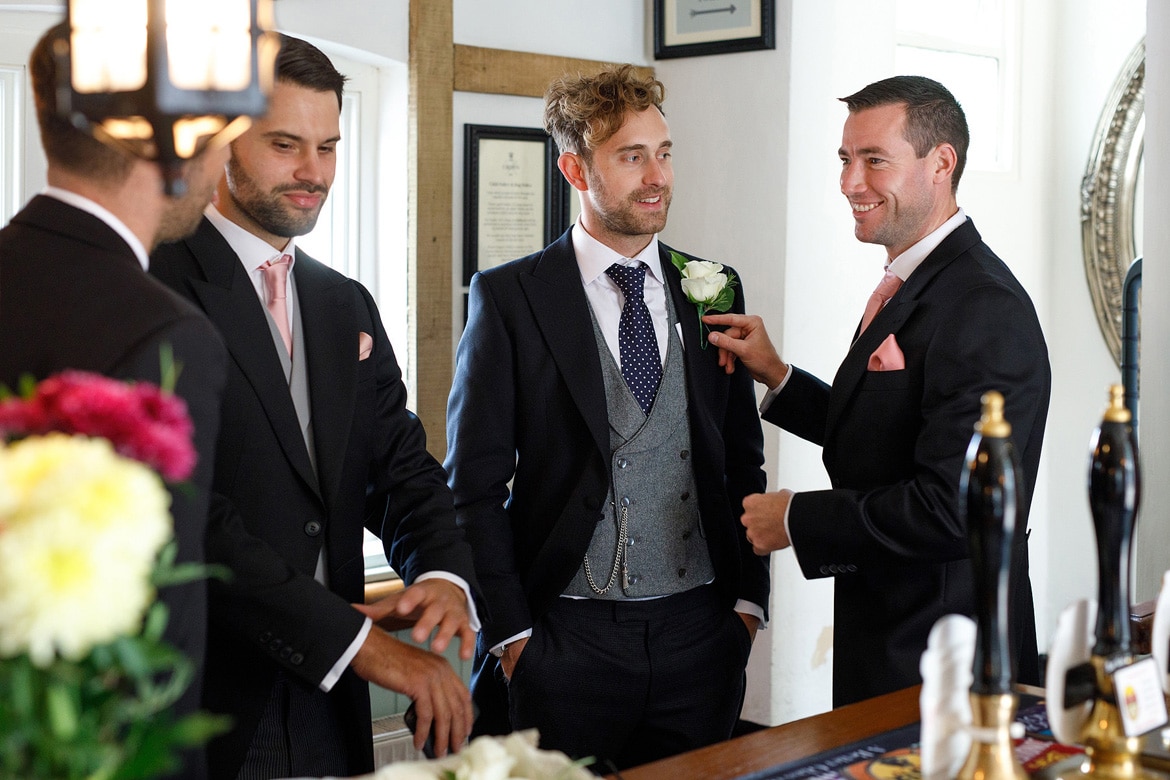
[840,76,971,193]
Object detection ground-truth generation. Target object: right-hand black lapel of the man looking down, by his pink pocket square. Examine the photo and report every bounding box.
[294,250,351,512]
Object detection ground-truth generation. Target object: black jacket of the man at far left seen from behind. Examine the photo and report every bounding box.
[0,195,227,776]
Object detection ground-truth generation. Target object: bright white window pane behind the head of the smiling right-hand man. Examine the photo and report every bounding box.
[894,46,1006,171]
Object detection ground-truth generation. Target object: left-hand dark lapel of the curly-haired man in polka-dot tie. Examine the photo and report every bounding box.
[519,228,610,454]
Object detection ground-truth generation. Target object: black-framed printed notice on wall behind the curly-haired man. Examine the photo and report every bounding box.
[463,124,571,285]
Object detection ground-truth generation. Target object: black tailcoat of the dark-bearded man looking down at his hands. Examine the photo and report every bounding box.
[151,219,475,778]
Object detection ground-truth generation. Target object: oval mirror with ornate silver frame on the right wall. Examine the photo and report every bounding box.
[1081,40,1145,365]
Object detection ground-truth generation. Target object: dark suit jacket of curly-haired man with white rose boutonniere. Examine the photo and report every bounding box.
[446,228,769,730]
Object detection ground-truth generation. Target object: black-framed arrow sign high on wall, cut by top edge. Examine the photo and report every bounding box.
[654,0,776,60]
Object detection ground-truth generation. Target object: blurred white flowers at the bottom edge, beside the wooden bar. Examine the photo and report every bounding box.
[372,730,593,780]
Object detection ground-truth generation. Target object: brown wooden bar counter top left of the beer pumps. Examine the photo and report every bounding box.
[611,686,920,780]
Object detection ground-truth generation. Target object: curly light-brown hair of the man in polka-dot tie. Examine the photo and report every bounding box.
[544,64,666,159]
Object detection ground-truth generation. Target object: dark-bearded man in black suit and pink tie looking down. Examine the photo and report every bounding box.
[151,36,477,779]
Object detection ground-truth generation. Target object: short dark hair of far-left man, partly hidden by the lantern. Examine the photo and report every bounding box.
[28,22,133,184]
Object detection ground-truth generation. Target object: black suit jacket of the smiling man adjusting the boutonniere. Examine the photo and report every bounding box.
[764,220,1052,705]
